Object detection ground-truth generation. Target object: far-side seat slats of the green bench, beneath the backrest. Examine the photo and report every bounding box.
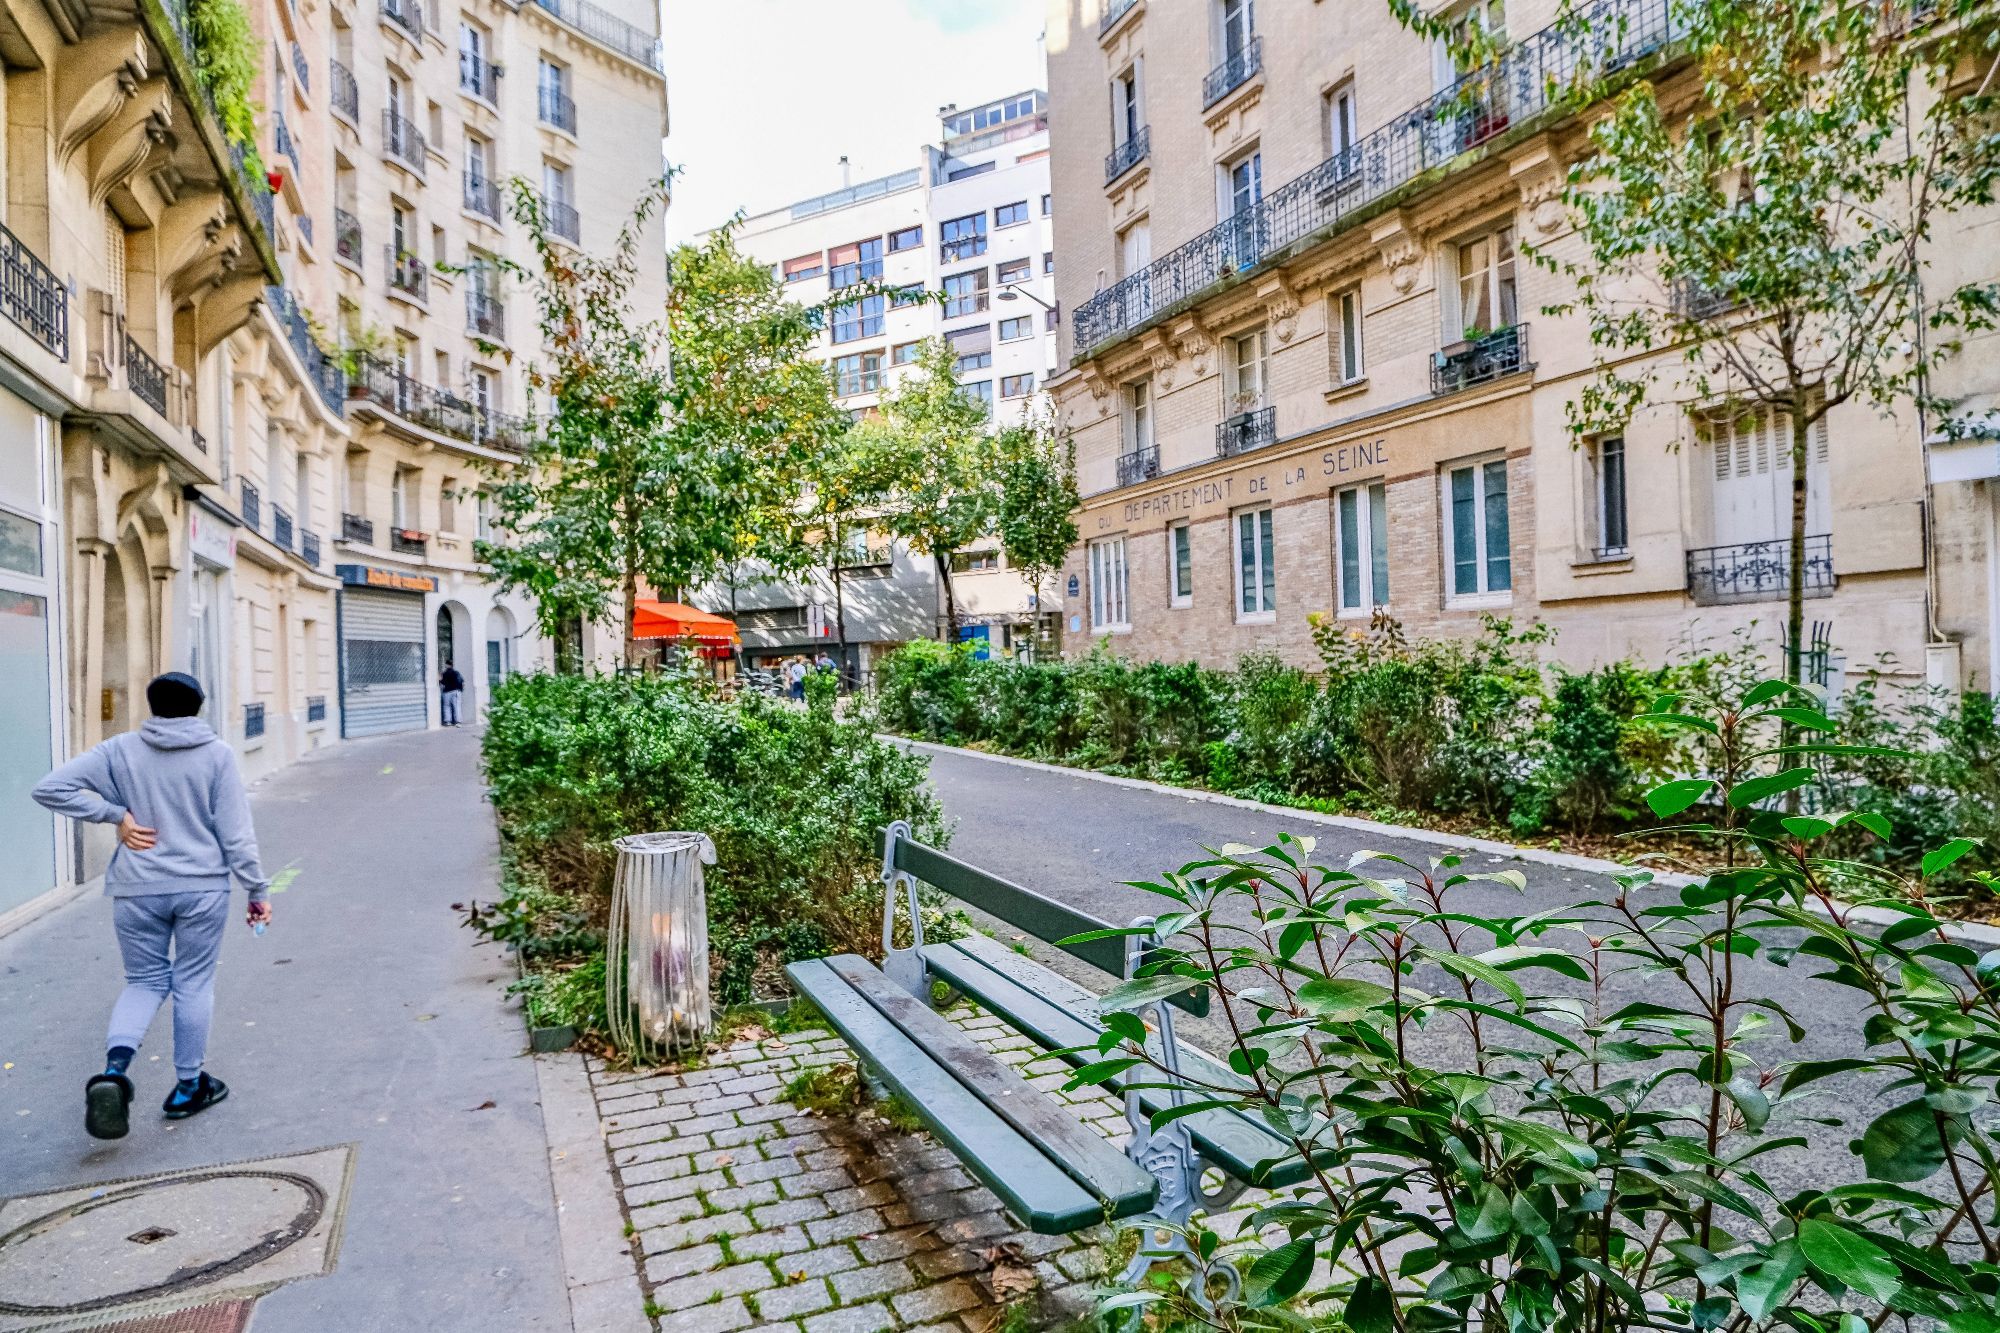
[924,935,1310,1189]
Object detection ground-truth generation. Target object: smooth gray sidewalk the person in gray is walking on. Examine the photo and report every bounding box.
[0,731,608,1333]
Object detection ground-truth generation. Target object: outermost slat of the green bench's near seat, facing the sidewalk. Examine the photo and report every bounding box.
[784,959,1138,1235]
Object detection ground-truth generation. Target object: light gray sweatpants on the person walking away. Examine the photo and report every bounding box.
[104,880,230,1079]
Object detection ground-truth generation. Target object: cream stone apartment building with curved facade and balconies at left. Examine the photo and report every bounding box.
[0,0,664,919]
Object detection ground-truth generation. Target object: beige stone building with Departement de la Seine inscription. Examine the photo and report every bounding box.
[1048,0,2000,689]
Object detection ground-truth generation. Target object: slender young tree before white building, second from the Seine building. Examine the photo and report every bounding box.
[856,338,996,640]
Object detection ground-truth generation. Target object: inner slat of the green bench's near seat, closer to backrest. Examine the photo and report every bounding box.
[826,955,1160,1217]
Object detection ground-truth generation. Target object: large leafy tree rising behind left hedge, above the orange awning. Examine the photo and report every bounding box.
[476,189,846,664]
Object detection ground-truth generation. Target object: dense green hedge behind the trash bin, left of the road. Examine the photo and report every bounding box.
[482,675,944,1003]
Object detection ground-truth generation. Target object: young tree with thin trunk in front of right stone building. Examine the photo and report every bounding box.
[1390,0,2000,685]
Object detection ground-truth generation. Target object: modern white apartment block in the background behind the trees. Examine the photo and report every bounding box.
[702,90,1058,671]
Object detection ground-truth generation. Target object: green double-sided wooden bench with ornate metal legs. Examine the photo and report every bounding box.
[786,823,1310,1285]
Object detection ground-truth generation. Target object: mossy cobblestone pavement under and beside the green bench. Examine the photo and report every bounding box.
[592,1005,1256,1333]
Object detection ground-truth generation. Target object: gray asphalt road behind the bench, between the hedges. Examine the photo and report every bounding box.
[930,751,1890,1195]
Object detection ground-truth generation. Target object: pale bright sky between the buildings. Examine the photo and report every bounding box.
[664,0,1046,240]
